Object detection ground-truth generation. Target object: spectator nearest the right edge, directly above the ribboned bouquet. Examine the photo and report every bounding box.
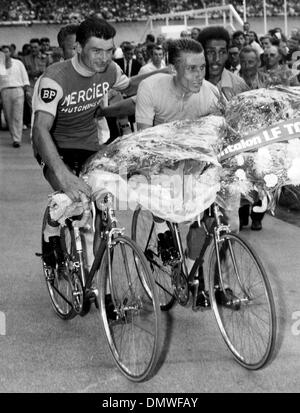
[261,45,300,86]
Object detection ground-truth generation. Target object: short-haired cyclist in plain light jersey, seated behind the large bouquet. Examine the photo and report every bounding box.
[136,38,219,307]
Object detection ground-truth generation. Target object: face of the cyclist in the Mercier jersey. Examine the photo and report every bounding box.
[81,36,114,72]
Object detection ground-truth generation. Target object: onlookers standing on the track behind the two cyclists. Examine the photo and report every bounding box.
[1,18,300,142]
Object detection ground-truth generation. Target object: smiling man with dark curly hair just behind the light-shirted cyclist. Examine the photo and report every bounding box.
[198,26,249,100]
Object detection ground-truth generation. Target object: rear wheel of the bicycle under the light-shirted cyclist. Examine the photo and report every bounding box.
[131,207,175,311]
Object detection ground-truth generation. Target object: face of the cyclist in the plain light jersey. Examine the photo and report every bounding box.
[176,52,206,93]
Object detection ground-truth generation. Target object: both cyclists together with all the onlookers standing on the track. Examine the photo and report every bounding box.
[0,16,300,307]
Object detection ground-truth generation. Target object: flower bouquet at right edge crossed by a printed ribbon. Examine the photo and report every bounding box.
[219,87,300,208]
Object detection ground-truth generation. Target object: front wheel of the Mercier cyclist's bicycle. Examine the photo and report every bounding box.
[95,236,162,382]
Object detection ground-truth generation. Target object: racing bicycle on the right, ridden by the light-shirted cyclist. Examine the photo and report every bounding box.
[132,204,276,370]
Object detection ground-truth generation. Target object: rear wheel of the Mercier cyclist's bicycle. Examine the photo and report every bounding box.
[41,209,77,320]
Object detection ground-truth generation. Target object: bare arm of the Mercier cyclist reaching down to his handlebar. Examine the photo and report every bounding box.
[32,111,90,201]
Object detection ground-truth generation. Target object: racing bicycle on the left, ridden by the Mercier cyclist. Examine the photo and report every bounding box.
[41,193,162,382]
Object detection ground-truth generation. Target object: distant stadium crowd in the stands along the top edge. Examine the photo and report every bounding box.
[0,0,300,23]
